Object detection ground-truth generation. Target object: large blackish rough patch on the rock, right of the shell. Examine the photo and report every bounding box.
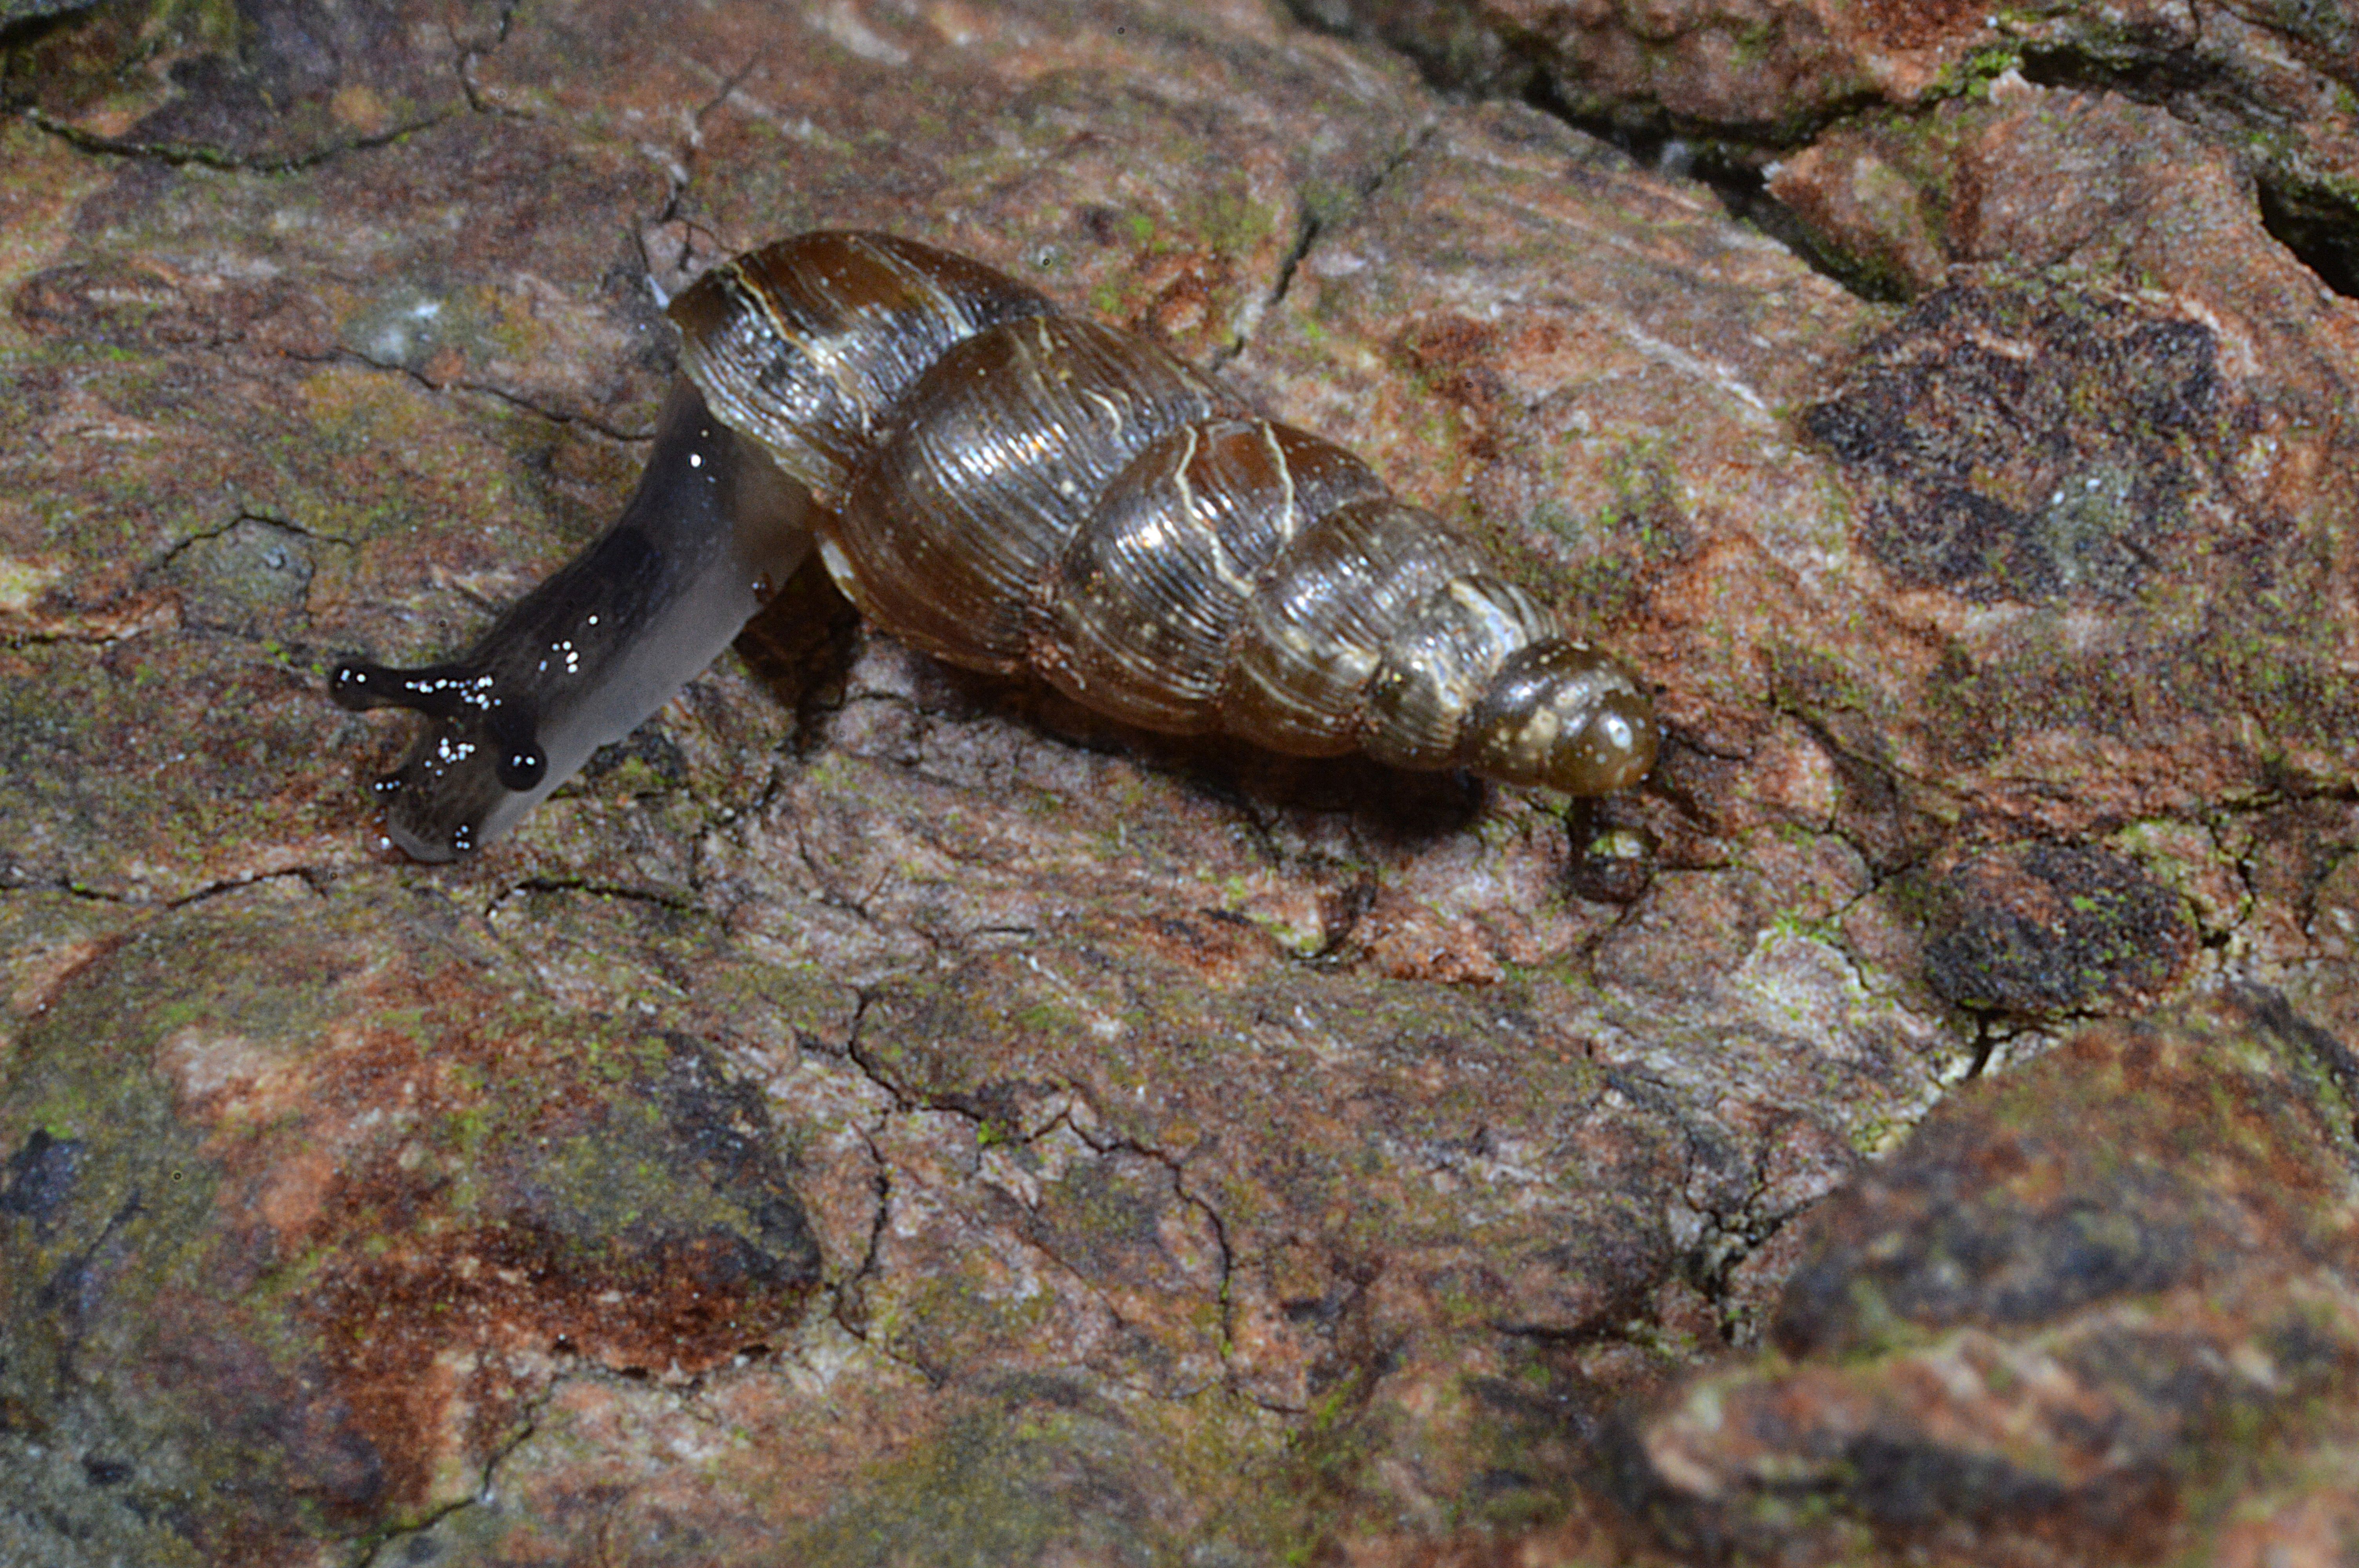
[1805,285,2232,601]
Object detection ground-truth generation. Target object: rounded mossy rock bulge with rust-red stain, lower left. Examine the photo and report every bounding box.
[0,884,819,1556]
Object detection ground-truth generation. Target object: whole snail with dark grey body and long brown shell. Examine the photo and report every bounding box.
[330,231,1656,860]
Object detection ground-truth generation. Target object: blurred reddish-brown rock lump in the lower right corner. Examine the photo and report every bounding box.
[1630,993,2359,1561]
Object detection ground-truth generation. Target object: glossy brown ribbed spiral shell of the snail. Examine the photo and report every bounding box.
[672,233,1656,795]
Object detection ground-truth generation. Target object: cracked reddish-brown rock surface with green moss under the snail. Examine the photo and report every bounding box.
[14,0,2359,1568]
